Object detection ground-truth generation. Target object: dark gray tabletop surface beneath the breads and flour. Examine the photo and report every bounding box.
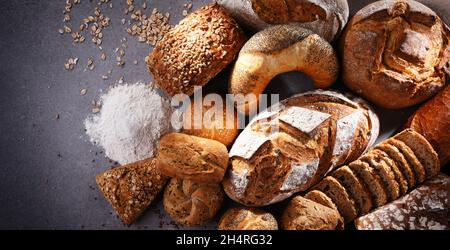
[0,0,449,229]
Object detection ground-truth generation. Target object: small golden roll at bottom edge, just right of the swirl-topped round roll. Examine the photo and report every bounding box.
[218,208,278,230]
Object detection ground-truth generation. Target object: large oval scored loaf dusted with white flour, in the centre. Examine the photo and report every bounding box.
[223,90,379,206]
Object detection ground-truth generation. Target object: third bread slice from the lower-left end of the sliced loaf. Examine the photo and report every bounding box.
[349,160,388,207]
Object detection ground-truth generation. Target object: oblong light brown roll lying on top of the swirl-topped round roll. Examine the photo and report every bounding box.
[156,133,228,183]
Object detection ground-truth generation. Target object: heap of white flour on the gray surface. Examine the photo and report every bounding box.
[85,83,172,165]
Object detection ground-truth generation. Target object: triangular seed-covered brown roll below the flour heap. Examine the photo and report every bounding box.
[95,158,168,225]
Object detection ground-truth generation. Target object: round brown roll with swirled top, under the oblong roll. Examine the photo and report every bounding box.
[163,178,224,226]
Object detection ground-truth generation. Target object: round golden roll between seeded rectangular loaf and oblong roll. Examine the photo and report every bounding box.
[183,95,239,146]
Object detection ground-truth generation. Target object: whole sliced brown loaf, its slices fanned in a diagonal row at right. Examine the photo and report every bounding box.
[305,129,439,223]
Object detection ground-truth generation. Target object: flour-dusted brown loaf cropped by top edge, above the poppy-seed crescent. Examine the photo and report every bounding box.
[218,0,349,41]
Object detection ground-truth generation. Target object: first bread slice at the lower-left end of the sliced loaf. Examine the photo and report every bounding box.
[313,176,358,223]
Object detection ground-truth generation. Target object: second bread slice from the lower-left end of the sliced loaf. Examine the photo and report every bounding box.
[331,166,373,215]
